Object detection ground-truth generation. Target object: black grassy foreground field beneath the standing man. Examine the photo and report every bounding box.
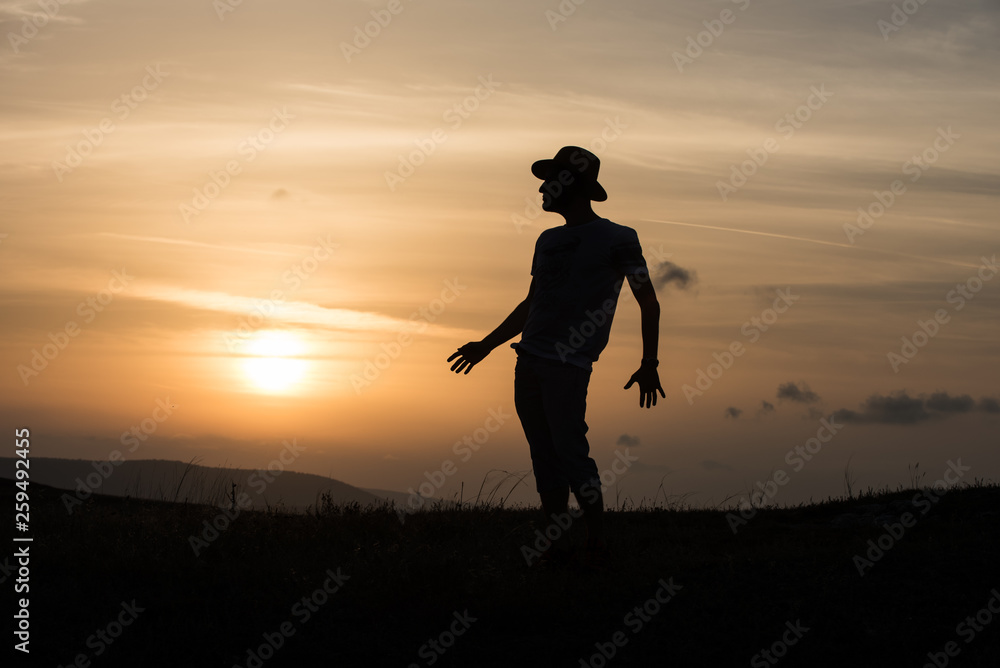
[3,480,1000,668]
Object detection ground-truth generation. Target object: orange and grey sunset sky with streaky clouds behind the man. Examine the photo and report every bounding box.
[0,0,1000,506]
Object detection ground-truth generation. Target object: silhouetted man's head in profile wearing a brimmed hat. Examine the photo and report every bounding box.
[531,146,608,213]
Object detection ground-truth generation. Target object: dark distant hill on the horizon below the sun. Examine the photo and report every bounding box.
[0,457,390,511]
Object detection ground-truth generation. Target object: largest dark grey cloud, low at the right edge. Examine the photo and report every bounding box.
[833,390,1000,424]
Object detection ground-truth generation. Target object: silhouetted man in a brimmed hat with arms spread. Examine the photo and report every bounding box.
[448,146,666,563]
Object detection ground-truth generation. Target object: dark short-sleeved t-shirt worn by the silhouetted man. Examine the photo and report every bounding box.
[511,218,648,370]
